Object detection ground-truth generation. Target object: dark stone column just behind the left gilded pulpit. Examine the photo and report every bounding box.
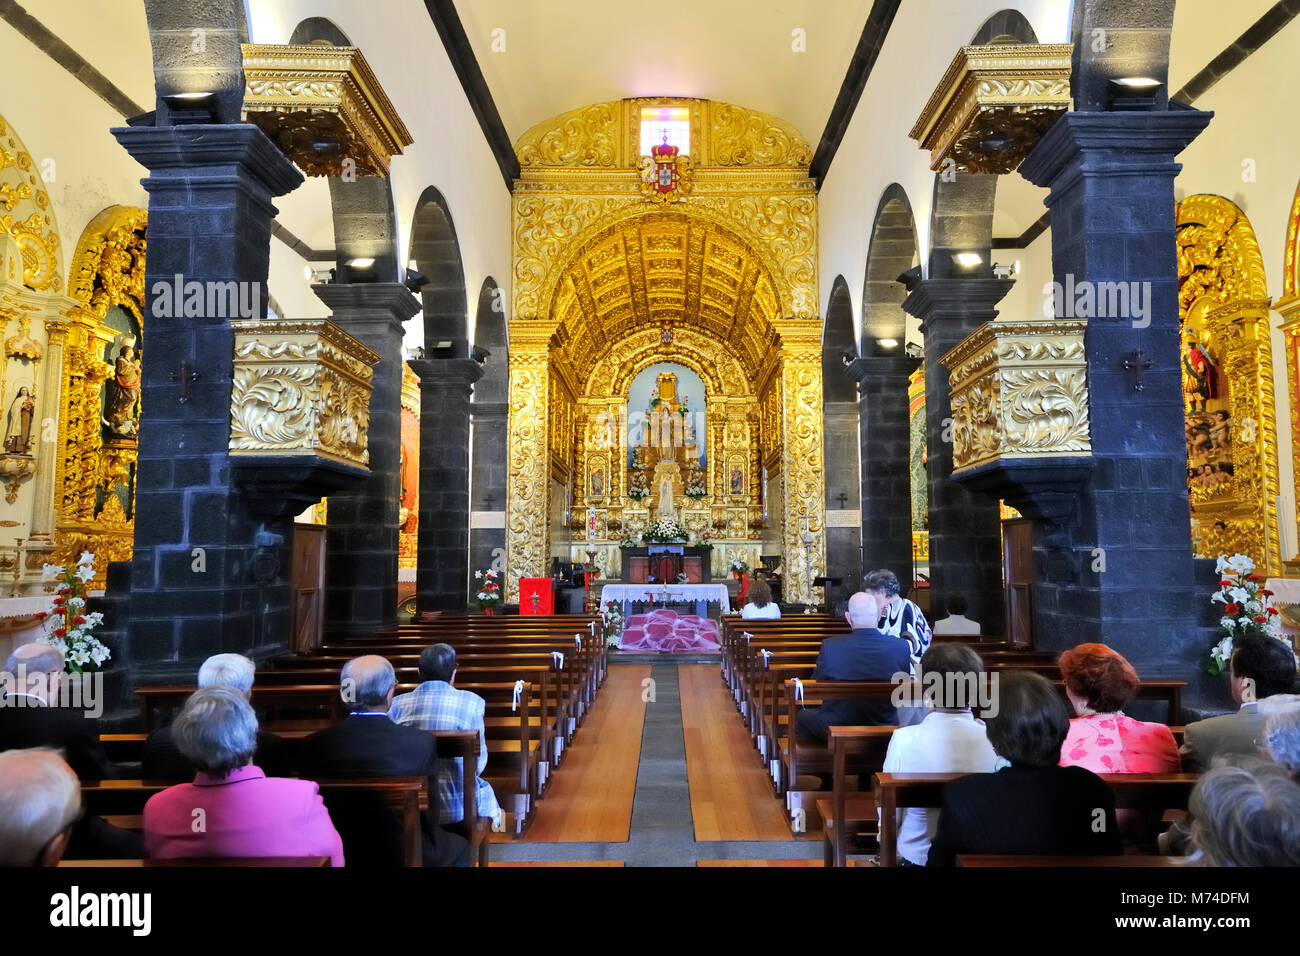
[313,282,420,637]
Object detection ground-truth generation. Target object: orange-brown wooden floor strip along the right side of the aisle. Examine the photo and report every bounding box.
[676,665,795,842]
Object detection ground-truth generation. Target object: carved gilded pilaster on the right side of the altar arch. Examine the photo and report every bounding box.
[774,319,827,604]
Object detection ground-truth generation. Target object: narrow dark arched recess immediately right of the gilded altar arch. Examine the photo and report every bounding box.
[822,276,863,604]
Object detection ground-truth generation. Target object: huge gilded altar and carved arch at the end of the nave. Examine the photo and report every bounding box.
[506,98,826,601]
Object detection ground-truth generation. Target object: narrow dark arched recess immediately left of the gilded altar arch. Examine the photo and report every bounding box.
[469,276,510,590]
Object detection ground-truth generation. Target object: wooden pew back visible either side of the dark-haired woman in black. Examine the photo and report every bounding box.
[872,773,1200,866]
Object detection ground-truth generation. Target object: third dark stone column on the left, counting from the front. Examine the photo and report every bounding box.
[410,359,482,613]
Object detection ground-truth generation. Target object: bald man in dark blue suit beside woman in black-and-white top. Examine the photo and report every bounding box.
[796,591,911,740]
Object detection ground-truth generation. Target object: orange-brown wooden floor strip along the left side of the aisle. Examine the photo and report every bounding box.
[506,665,650,843]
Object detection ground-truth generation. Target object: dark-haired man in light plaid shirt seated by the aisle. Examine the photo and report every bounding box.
[389,644,501,829]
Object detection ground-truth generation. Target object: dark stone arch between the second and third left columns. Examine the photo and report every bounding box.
[408,186,468,358]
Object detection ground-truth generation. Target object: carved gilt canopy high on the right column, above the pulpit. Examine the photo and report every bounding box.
[909,43,1074,173]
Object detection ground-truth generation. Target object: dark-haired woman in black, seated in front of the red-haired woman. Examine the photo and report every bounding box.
[926,671,1123,866]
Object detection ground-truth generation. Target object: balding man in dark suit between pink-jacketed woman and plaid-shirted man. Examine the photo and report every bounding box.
[298,654,469,866]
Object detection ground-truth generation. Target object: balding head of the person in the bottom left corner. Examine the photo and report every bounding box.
[0,749,82,866]
